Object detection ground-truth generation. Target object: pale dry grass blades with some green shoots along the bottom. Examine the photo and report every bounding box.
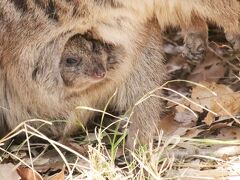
[0,81,240,180]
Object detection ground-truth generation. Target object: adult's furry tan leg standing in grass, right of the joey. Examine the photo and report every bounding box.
[113,21,165,150]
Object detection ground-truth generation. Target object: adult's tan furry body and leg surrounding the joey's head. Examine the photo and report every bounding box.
[0,0,240,146]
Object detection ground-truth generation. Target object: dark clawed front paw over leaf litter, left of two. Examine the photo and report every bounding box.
[182,32,207,60]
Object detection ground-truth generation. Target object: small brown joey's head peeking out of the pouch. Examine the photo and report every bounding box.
[60,34,118,89]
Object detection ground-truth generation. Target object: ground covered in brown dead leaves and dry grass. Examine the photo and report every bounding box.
[0,27,240,180]
